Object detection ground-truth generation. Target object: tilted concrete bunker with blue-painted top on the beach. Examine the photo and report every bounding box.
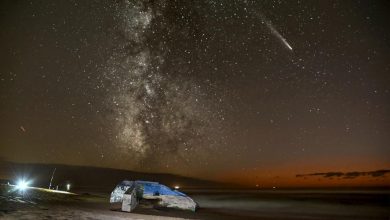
[110,180,197,212]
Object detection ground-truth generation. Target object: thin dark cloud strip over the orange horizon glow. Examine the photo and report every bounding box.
[296,170,390,179]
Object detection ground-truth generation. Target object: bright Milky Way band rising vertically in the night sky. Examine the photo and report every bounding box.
[100,1,222,168]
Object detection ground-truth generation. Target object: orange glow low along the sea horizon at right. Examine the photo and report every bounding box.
[219,163,390,188]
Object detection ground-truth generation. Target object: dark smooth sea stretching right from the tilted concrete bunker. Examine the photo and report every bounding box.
[187,189,390,220]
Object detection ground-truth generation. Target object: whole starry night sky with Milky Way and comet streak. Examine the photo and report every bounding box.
[0,0,390,186]
